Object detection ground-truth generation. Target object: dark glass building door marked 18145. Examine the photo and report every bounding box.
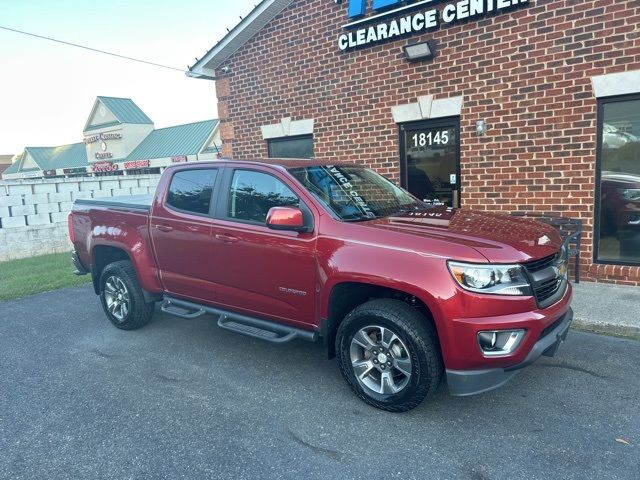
[400,117,460,208]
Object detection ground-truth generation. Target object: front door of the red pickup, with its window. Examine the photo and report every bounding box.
[212,167,317,327]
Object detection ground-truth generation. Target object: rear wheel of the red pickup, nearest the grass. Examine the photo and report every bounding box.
[100,260,155,330]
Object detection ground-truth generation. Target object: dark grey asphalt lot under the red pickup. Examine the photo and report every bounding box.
[0,286,640,480]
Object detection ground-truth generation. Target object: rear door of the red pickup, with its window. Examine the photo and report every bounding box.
[150,167,220,302]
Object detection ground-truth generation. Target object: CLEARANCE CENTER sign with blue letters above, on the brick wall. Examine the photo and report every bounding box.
[336,0,529,51]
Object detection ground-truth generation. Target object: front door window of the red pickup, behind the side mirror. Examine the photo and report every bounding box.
[227,170,300,223]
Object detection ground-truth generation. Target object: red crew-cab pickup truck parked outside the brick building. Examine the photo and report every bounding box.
[69,159,573,411]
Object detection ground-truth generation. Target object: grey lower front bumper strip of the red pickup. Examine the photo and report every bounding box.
[446,309,573,396]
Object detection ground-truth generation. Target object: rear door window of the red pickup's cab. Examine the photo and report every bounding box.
[167,169,218,215]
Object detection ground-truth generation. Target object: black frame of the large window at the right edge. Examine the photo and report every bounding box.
[592,93,640,267]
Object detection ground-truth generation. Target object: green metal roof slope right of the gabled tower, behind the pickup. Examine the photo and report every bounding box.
[127,120,218,160]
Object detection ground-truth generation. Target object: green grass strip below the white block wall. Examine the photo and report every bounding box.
[0,253,91,301]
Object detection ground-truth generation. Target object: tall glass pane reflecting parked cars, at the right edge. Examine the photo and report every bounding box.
[594,95,640,264]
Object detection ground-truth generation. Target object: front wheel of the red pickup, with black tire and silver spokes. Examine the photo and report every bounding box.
[336,299,443,412]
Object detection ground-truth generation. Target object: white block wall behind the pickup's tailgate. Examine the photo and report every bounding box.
[0,175,160,261]
